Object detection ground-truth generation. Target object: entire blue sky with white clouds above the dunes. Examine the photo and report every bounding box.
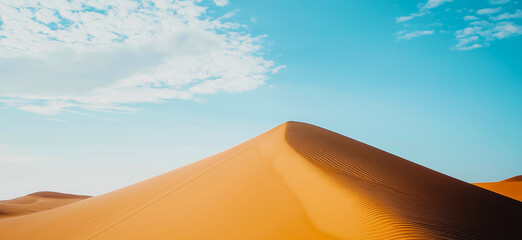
[0,0,522,198]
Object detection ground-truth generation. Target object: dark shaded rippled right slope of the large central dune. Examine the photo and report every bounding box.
[287,123,522,239]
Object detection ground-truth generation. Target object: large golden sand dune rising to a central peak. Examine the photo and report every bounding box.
[0,122,522,240]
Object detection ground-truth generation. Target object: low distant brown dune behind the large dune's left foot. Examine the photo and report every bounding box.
[0,192,90,218]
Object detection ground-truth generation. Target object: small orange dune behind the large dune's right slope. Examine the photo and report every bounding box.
[474,175,522,202]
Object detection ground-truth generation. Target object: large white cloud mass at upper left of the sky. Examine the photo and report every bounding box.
[0,0,280,115]
